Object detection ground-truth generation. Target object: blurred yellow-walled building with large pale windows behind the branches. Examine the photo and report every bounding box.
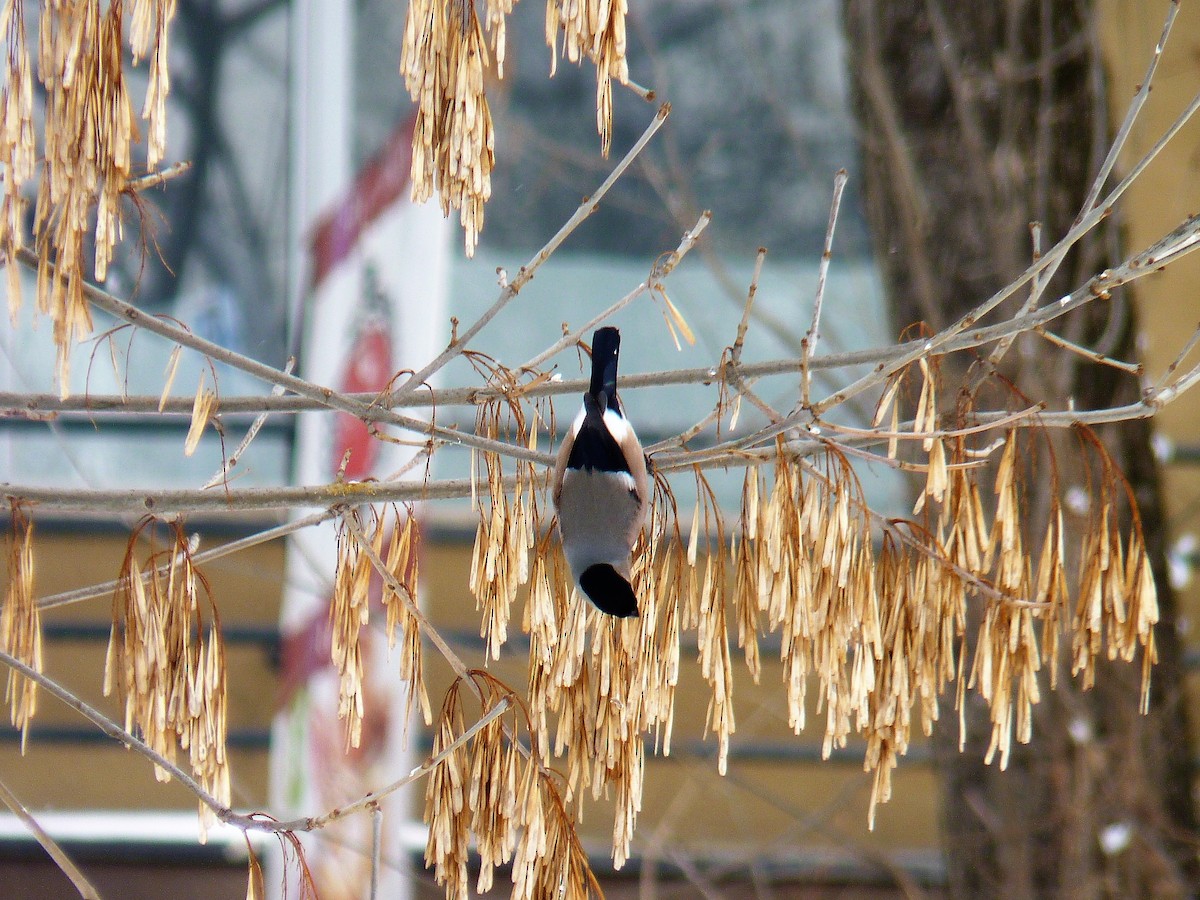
[0,0,1200,900]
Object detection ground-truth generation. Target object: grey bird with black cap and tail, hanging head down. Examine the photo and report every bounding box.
[553,328,649,617]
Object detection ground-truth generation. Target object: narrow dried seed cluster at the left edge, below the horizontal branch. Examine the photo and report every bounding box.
[0,506,42,754]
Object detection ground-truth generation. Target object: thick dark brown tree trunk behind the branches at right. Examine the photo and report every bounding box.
[844,0,1200,898]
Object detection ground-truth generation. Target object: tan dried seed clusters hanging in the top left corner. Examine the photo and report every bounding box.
[0,0,175,392]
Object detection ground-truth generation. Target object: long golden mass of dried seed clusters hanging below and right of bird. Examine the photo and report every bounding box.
[451,364,1158,865]
